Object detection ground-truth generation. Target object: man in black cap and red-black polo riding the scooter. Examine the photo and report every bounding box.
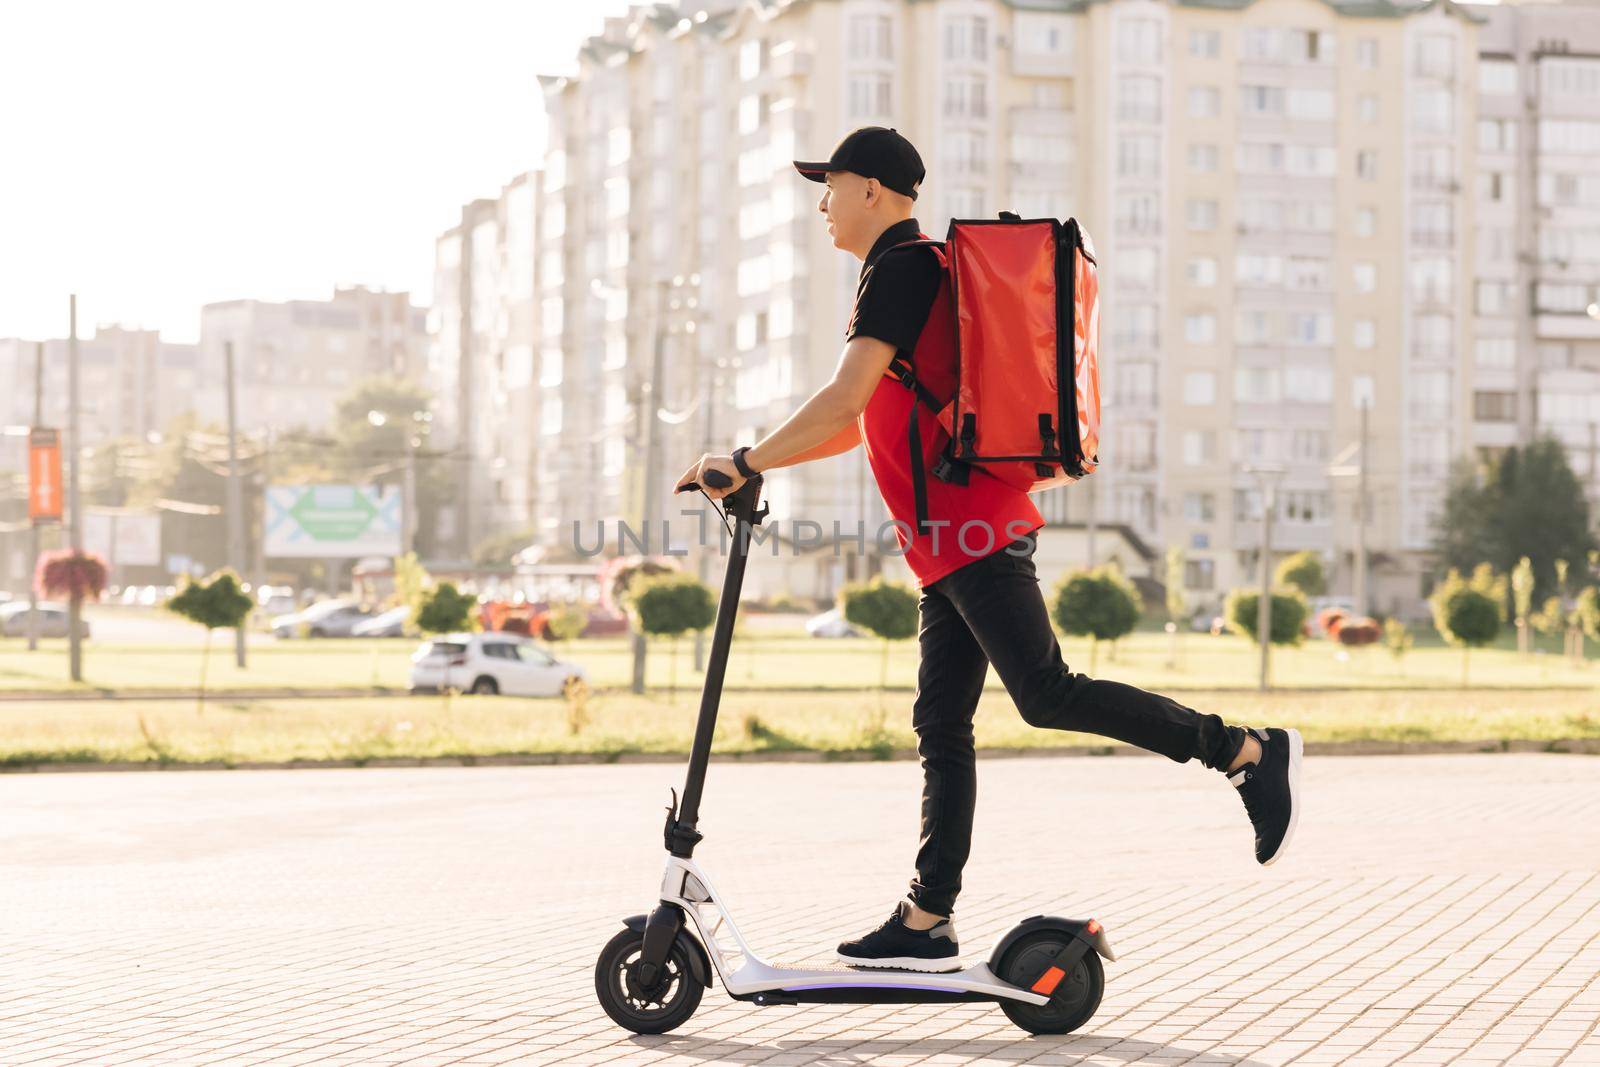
[678,126,1301,971]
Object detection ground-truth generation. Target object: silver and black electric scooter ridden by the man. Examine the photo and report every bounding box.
[595,470,1117,1033]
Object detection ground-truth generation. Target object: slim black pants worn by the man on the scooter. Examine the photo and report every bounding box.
[910,537,1245,915]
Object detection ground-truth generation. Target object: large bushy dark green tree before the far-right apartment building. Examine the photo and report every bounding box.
[1434,437,1597,598]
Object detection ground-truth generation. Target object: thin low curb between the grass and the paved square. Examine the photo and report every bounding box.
[0,737,1600,774]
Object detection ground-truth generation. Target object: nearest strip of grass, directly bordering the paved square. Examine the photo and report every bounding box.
[0,691,1600,768]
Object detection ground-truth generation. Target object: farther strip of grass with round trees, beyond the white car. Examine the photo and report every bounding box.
[0,632,1600,699]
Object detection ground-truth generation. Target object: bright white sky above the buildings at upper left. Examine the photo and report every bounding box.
[0,0,627,341]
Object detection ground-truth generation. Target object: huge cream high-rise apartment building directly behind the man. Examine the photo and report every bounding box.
[534,0,1497,611]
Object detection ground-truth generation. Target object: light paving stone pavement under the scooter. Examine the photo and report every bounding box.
[0,755,1600,1067]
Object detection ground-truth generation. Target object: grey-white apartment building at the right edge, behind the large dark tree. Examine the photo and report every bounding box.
[1470,3,1600,507]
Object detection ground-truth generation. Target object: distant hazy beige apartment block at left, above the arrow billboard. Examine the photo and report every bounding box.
[198,286,426,434]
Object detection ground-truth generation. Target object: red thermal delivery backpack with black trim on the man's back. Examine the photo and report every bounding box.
[888,211,1099,533]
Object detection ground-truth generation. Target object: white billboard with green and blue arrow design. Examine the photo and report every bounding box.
[266,485,400,560]
